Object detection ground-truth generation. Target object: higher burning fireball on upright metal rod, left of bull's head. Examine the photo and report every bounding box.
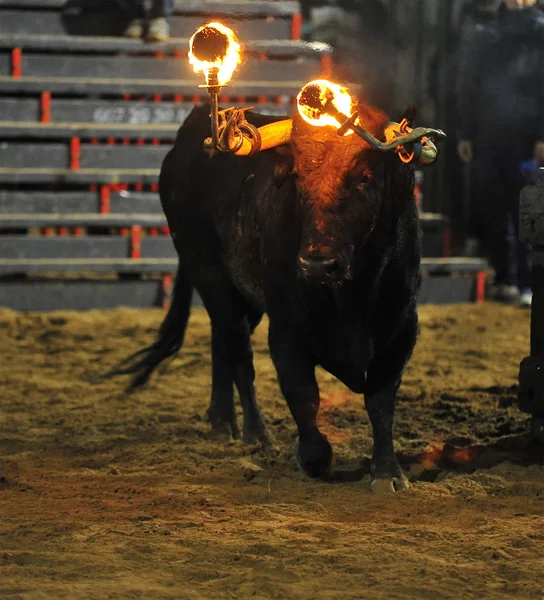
[189,23,242,85]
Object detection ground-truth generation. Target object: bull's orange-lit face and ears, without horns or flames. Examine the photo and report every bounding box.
[291,106,413,286]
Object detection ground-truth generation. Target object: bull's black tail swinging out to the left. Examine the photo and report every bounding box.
[108,265,193,392]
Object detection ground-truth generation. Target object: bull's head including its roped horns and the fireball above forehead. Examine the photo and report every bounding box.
[214,82,445,285]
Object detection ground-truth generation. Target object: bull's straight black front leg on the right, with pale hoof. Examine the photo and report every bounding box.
[365,312,417,493]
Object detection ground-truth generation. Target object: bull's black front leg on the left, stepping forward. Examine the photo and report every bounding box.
[268,321,332,477]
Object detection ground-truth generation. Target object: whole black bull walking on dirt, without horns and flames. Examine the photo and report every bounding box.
[117,102,420,491]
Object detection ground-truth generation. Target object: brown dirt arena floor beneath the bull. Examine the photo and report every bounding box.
[0,304,544,600]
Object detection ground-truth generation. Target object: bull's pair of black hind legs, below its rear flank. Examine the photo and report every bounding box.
[197,276,266,443]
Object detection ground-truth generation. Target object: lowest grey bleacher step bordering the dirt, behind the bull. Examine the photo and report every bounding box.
[0,258,486,310]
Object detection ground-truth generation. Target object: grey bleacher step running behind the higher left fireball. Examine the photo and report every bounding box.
[0,34,330,91]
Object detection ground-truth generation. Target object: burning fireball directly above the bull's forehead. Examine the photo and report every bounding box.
[297,79,355,135]
